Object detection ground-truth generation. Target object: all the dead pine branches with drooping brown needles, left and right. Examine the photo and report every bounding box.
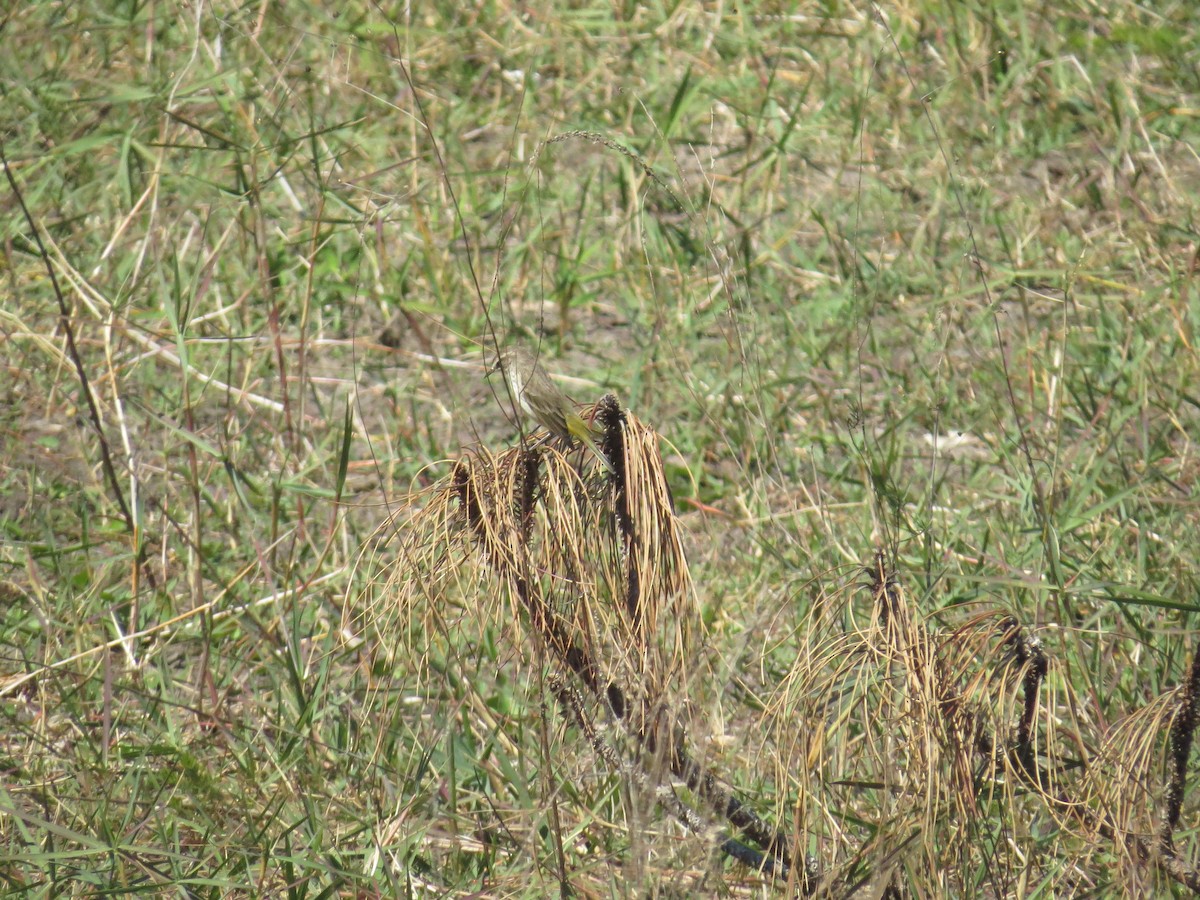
[343,405,1200,895]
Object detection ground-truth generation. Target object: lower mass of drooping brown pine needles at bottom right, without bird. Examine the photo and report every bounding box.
[758,554,1200,896]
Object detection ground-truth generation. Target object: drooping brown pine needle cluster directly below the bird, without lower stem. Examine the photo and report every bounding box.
[367,397,696,695]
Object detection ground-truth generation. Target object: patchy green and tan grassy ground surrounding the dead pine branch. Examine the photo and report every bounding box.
[0,0,1200,896]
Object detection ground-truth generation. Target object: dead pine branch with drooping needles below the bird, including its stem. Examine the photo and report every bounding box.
[352,395,816,888]
